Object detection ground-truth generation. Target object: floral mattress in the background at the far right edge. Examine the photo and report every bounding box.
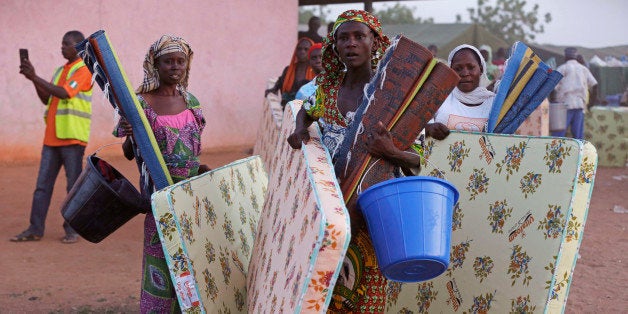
[584,106,628,167]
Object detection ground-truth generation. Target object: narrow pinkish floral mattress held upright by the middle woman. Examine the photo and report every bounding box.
[247,100,351,313]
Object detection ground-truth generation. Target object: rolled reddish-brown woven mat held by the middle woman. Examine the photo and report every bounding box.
[334,36,459,208]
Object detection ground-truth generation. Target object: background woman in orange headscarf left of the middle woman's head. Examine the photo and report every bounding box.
[264,37,315,108]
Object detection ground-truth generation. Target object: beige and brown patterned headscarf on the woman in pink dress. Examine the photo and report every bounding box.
[135,35,194,94]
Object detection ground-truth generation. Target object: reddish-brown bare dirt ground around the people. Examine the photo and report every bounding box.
[0,150,628,313]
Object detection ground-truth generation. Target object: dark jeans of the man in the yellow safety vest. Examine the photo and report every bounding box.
[28,145,85,236]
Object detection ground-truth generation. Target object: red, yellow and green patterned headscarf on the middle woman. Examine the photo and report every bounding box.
[308,10,390,126]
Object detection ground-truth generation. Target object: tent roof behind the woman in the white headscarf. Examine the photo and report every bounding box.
[382,23,511,59]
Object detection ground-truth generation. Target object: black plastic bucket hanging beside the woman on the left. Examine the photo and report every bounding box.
[61,155,148,243]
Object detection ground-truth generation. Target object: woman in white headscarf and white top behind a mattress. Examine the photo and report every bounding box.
[425,44,495,140]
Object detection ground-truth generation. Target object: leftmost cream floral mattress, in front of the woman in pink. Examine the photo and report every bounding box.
[152,156,268,313]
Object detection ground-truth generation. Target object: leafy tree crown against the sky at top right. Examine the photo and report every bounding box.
[456,0,552,43]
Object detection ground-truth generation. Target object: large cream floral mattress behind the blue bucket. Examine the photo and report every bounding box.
[386,131,597,313]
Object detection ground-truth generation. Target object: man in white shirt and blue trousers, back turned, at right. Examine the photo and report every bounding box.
[552,47,597,139]
